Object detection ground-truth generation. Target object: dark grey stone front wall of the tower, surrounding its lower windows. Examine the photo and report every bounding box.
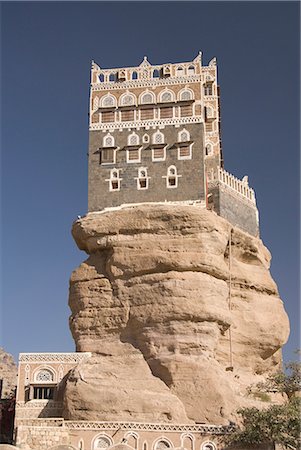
[88,123,205,211]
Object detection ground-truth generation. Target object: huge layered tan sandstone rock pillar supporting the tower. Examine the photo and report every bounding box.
[65,205,289,424]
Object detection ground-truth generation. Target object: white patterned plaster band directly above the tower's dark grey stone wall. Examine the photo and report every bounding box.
[89,116,202,131]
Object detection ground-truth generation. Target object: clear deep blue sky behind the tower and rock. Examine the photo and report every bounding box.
[0,2,300,360]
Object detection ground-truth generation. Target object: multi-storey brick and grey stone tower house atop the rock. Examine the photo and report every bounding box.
[88,53,258,235]
